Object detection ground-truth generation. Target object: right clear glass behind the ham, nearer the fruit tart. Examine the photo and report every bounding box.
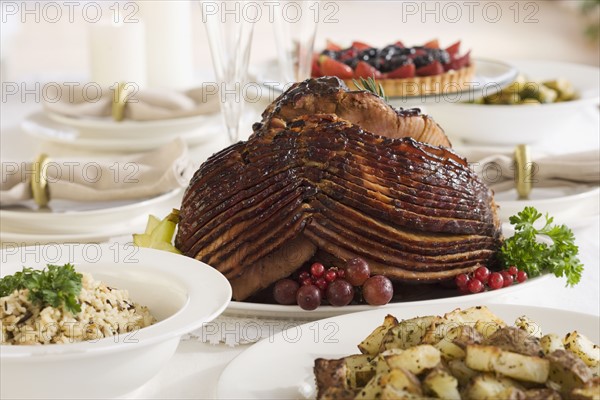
[273,0,319,87]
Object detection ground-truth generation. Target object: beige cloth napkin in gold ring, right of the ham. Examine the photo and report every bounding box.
[464,150,600,191]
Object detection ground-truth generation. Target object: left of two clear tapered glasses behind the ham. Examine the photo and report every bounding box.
[200,0,254,143]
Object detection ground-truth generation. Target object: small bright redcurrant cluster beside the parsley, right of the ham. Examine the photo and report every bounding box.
[454,266,527,294]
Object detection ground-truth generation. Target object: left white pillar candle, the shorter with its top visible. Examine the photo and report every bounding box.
[90,20,146,88]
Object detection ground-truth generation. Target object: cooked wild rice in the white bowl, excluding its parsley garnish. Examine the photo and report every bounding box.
[0,273,156,345]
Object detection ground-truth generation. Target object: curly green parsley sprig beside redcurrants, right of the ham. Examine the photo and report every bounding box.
[500,207,583,286]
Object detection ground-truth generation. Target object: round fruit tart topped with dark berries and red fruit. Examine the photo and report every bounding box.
[312,40,475,97]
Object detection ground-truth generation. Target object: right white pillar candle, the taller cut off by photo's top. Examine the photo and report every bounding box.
[138,0,194,89]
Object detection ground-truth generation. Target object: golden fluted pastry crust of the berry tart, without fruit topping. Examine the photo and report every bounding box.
[344,62,475,97]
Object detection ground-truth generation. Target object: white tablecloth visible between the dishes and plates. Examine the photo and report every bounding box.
[0,79,600,399]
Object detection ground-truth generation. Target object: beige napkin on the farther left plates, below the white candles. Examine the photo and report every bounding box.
[44,85,219,121]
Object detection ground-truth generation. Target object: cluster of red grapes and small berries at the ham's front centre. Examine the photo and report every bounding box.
[273,258,394,310]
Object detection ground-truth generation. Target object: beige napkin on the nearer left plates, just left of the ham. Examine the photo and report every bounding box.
[0,139,195,206]
